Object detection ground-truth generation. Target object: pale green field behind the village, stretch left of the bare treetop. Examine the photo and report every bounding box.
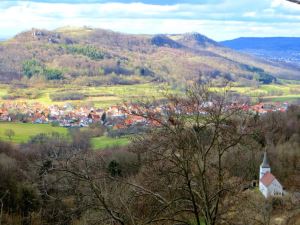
[0,83,169,108]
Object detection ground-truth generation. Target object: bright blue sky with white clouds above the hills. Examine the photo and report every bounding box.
[0,0,300,41]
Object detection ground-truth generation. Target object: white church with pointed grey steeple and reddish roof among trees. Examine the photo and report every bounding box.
[259,152,283,198]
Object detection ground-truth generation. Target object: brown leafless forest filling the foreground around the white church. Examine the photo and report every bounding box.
[0,86,300,225]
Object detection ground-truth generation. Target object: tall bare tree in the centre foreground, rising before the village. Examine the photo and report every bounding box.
[127,85,258,225]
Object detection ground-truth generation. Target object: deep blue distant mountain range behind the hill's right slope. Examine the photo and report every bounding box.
[220,37,300,67]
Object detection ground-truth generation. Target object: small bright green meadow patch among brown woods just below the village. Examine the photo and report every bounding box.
[91,136,130,150]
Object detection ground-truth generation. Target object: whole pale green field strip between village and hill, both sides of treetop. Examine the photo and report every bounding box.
[0,81,300,108]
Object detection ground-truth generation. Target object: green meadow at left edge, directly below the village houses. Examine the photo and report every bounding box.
[0,122,68,143]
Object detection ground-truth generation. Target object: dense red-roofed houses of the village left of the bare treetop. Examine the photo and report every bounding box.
[0,103,159,129]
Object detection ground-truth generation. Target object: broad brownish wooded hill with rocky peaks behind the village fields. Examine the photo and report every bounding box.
[0,27,300,85]
